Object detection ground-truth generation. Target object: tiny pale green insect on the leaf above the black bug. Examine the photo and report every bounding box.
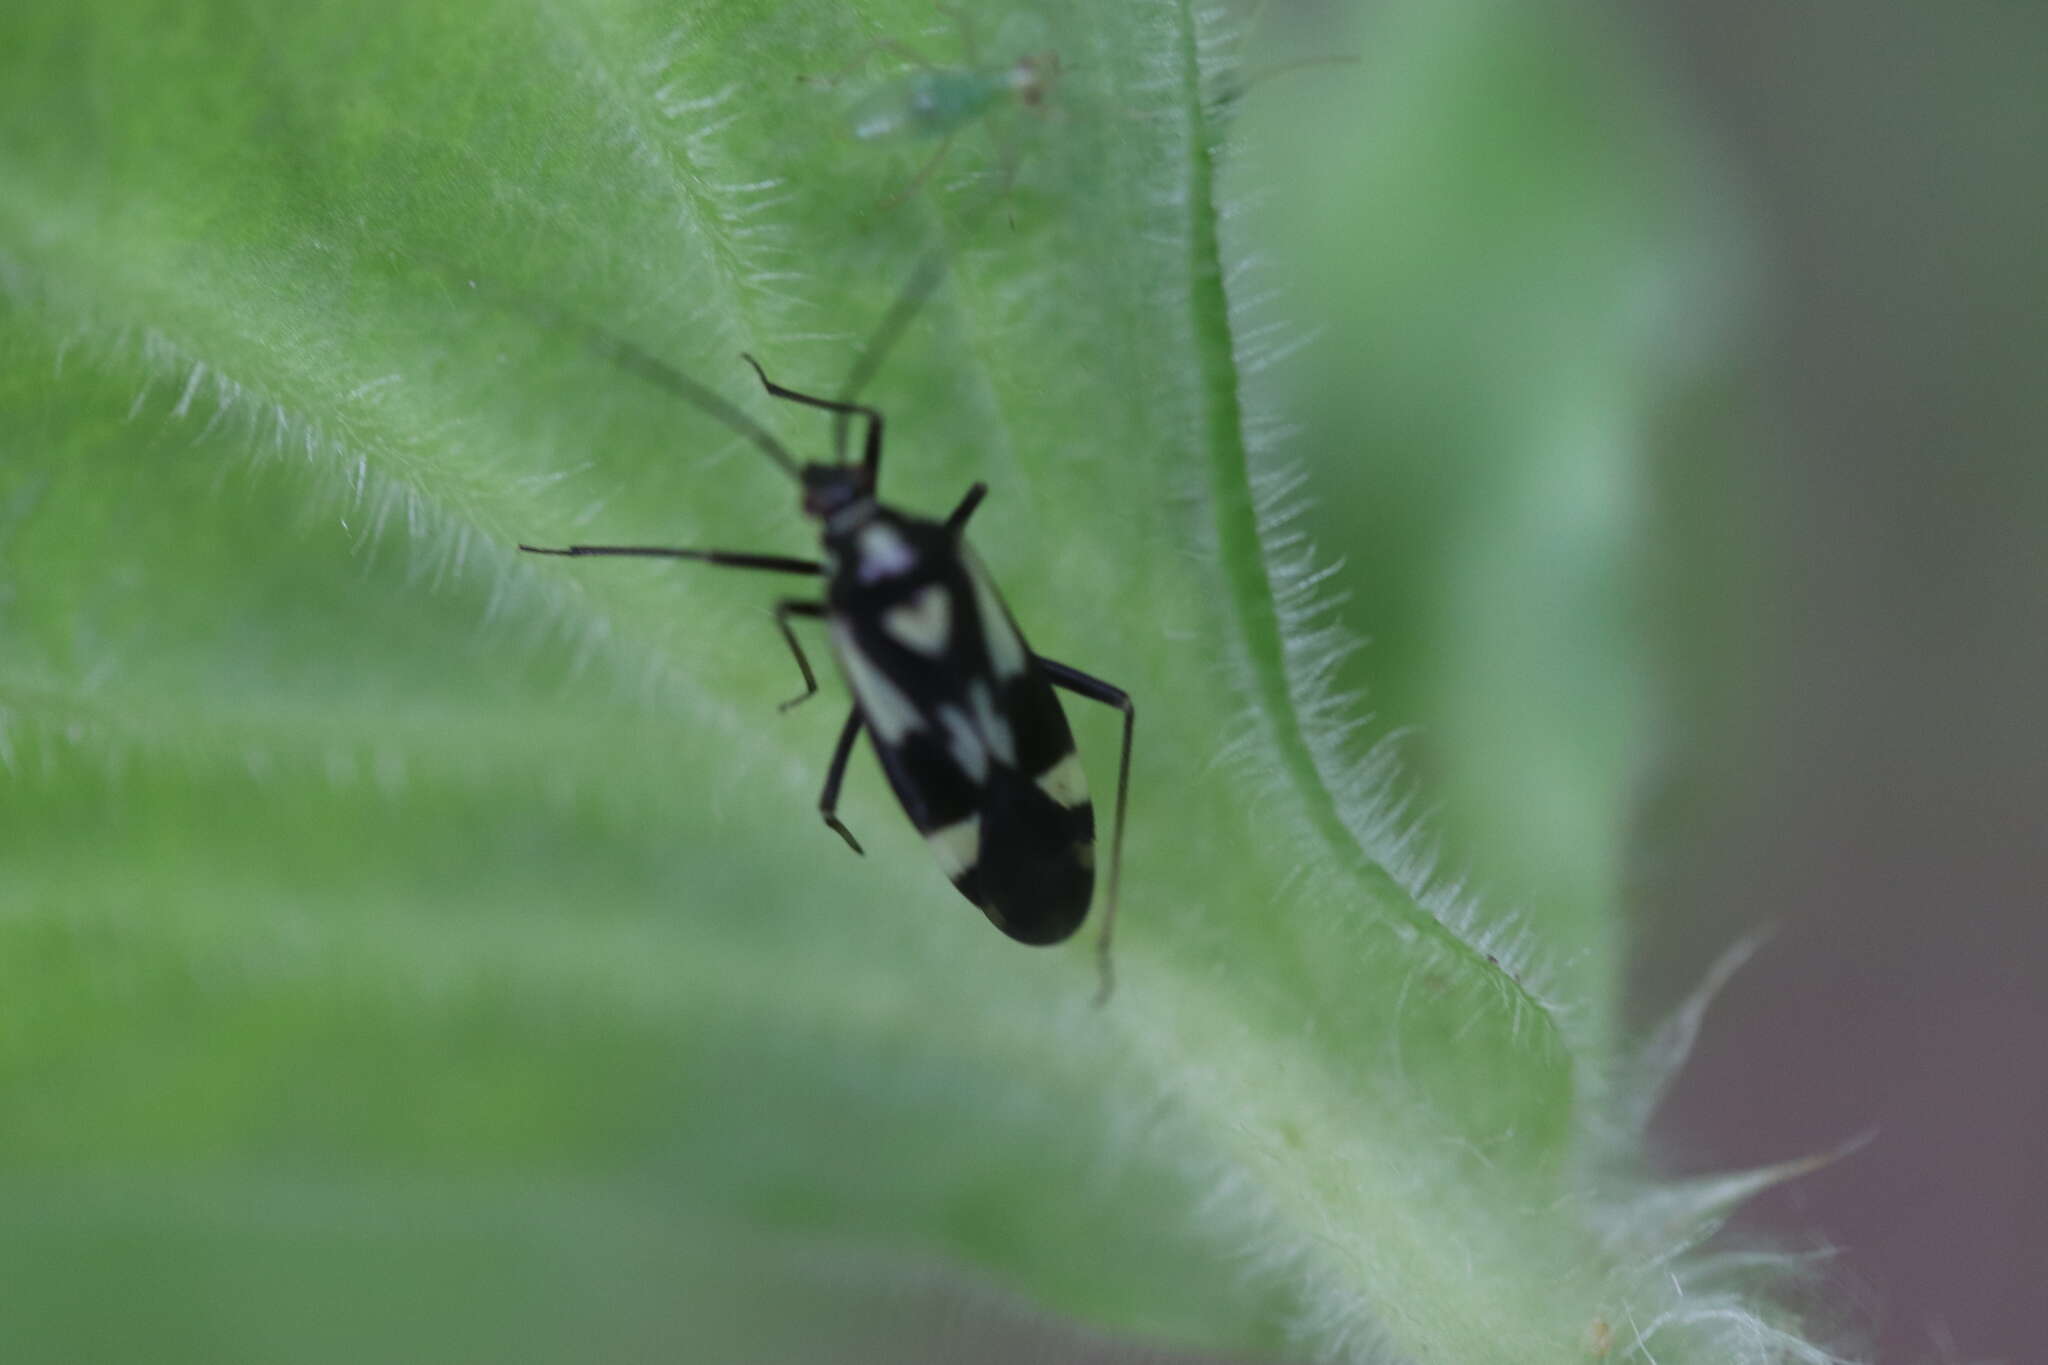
[813,10,1059,209]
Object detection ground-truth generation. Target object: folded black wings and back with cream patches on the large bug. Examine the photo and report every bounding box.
[827,512,1096,943]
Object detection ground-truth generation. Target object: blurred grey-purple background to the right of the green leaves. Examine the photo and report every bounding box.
[1634,4,2048,1361]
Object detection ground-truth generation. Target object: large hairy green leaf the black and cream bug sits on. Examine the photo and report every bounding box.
[0,0,1851,1365]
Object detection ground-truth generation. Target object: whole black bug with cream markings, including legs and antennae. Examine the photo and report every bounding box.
[518,280,1137,1001]
